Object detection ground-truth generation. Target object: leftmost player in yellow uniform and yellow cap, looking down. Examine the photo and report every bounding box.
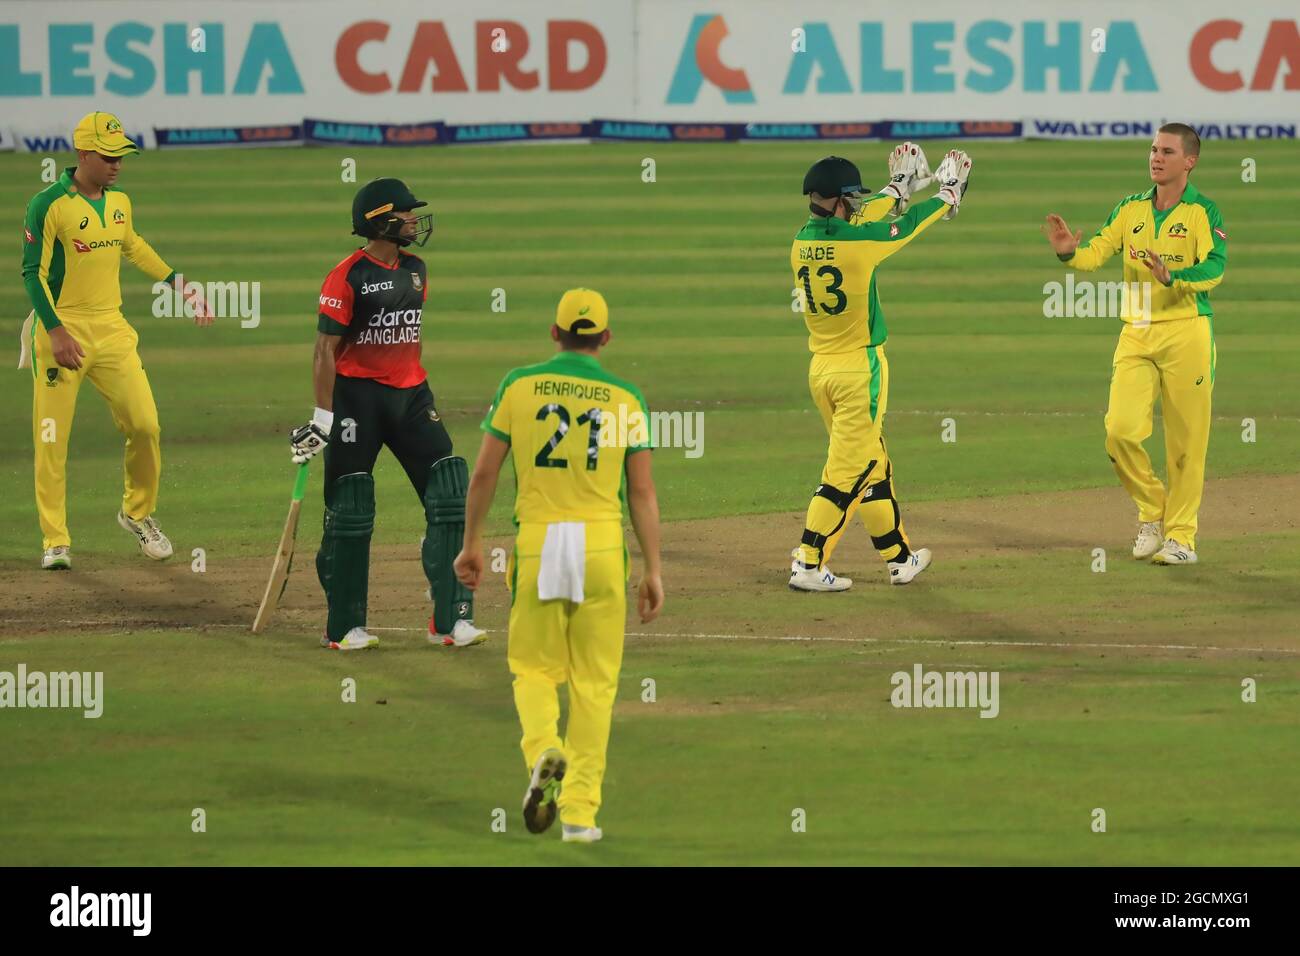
[18,113,212,570]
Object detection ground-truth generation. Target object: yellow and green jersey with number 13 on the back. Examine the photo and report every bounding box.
[790,195,948,354]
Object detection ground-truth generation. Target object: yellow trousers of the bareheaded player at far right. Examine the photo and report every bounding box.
[1106,315,1216,549]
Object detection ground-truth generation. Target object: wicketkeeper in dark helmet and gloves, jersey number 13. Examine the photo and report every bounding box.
[790,143,971,591]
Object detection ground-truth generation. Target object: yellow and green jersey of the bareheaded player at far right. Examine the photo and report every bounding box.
[1057,183,1227,321]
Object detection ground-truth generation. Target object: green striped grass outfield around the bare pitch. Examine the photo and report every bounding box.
[0,142,1300,864]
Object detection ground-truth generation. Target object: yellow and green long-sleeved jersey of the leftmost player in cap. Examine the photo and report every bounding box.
[22,169,176,329]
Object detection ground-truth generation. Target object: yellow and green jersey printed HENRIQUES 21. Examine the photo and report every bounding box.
[482,351,650,524]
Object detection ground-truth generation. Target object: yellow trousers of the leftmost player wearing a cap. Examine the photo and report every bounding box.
[31,312,163,548]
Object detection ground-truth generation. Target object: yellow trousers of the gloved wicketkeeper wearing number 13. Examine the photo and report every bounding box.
[800,346,910,567]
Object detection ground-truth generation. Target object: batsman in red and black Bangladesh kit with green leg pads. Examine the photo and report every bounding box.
[289,179,486,650]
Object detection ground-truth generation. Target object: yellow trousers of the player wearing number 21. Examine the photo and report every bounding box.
[507,522,628,826]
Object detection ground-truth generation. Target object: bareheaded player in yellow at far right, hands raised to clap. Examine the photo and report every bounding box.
[1047,122,1227,564]
